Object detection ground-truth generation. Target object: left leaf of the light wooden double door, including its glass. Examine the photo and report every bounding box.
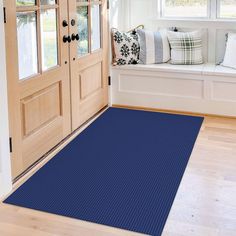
[5,0,71,178]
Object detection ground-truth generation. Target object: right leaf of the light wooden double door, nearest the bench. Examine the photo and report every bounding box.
[69,0,108,130]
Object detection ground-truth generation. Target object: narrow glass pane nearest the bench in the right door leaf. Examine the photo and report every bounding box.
[91,5,101,51]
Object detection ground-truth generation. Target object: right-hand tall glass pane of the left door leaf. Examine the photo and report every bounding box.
[41,9,58,71]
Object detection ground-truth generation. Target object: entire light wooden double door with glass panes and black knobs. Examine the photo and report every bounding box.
[4,0,108,178]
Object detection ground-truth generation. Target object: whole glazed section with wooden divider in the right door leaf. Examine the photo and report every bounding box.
[76,0,102,57]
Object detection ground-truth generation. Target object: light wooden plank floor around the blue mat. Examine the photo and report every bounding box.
[0,111,236,236]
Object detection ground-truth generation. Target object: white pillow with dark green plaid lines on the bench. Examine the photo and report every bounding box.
[167,31,203,65]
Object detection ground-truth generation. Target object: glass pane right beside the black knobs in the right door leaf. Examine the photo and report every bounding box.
[77,6,89,57]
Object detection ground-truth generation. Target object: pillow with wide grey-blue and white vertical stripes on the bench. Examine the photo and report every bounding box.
[137,30,170,64]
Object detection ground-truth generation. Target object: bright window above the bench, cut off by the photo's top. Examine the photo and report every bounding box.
[159,0,236,19]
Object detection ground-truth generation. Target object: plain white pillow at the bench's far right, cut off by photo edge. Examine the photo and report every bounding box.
[221,33,236,69]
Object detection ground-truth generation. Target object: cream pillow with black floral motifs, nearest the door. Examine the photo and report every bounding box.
[112,29,140,65]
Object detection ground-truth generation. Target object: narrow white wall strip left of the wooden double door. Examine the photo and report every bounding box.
[0,0,12,198]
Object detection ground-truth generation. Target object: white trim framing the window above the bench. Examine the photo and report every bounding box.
[157,0,236,22]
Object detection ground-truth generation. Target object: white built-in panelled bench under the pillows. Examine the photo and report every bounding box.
[111,63,236,117]
